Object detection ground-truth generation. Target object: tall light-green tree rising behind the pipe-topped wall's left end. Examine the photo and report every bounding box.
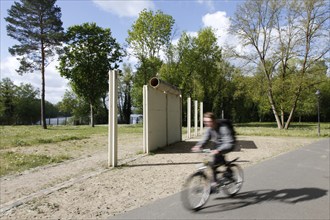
[126,9,174,111]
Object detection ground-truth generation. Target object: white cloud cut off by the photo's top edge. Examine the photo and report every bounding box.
[93,0,155,17]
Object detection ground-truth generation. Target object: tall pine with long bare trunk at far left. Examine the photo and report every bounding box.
[5,0,63,129]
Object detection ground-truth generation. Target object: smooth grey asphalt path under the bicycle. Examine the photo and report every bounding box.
[111,138,330,220]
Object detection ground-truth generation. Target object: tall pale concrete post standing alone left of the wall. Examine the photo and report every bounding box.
[108,70,118,167]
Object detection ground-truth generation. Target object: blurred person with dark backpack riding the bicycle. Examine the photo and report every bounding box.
[191,112,235,190]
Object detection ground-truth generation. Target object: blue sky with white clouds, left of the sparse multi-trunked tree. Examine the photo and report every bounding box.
[0,0,242,104]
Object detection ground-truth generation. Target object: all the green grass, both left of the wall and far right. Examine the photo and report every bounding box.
[0,123,330,176]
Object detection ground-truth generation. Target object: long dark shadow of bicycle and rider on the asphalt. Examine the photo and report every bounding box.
[199,188,328,214]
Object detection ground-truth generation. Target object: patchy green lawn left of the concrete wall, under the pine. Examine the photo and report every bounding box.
[0,125,143,176]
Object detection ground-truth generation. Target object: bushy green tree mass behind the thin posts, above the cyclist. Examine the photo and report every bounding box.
[160,28,235,124]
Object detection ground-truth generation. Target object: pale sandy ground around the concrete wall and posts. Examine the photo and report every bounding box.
[0,136,316,219]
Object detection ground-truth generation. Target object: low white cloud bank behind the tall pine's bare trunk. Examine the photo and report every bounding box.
[0,56,68,104]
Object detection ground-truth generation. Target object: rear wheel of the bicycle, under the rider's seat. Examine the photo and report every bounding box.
[223,164,244,196]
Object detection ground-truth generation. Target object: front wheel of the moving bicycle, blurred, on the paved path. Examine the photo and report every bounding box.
[181,172,211,211]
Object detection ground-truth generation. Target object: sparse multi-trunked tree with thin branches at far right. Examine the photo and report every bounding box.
[231,0,329,129]
